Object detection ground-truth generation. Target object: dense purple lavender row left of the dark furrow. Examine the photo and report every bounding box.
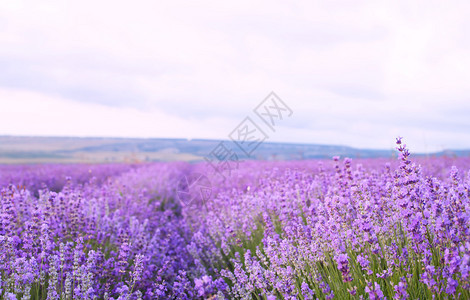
[0,164,225,299]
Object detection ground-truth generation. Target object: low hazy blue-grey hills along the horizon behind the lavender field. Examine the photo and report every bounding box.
[0,136,470,163]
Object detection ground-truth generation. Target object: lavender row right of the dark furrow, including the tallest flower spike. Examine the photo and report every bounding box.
[208,139,470,299]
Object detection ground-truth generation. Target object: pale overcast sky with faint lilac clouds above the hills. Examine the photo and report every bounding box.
[0,0,470,151]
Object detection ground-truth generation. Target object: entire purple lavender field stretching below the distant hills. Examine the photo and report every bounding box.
[0,139,470,300]
